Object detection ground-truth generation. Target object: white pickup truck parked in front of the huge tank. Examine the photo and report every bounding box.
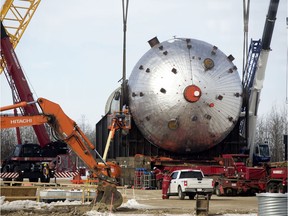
[167,169,213,200]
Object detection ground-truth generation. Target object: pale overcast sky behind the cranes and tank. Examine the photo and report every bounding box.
[0,0,287,127]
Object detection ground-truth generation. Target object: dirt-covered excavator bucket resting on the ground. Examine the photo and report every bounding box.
[92,185,123,211]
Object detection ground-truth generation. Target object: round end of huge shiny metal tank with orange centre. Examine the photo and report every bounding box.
[128,38,242,153]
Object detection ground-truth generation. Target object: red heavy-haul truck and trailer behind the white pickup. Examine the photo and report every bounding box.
[154,154,287,196]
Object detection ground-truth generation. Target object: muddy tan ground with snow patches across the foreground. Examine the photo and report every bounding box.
[1,189,258,216]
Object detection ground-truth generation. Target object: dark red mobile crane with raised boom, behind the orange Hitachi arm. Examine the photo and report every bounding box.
[0,21,77,182]
